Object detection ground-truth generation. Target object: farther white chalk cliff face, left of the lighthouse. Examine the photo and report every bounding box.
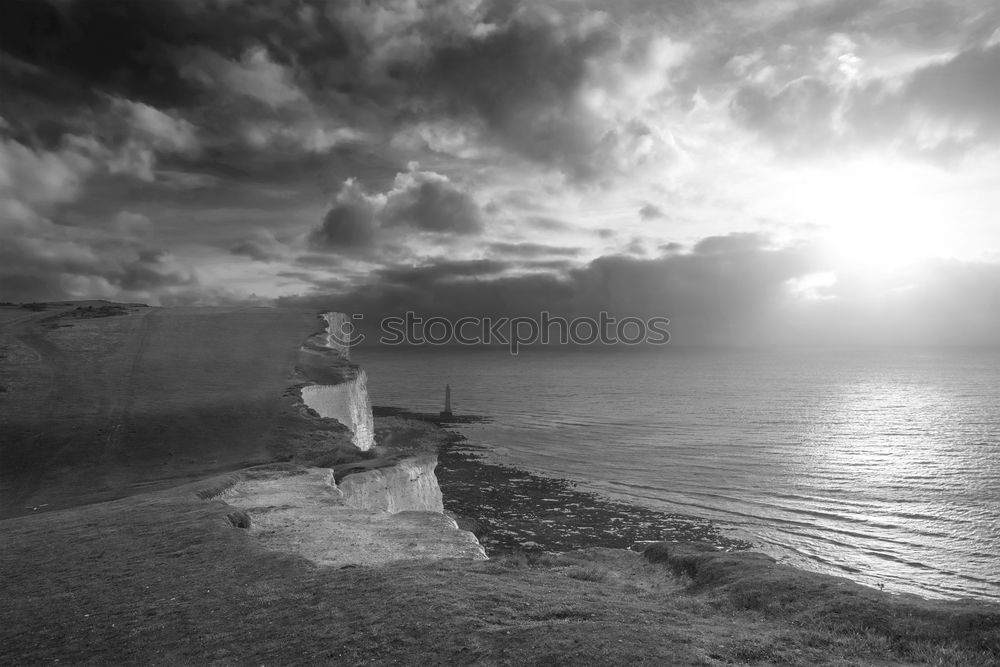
[297,313,375,451]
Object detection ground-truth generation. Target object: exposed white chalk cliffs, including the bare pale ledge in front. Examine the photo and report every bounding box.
[218,313,486,565]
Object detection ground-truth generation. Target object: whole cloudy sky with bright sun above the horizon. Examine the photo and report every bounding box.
[0,0,1000,344]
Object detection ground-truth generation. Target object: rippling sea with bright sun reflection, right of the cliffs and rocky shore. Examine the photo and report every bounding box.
[353,346,1000,600]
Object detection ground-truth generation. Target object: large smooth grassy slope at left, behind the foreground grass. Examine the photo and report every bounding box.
[0,304,322,517]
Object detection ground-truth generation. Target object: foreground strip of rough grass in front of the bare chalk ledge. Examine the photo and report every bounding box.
[0,488,1000,665]
